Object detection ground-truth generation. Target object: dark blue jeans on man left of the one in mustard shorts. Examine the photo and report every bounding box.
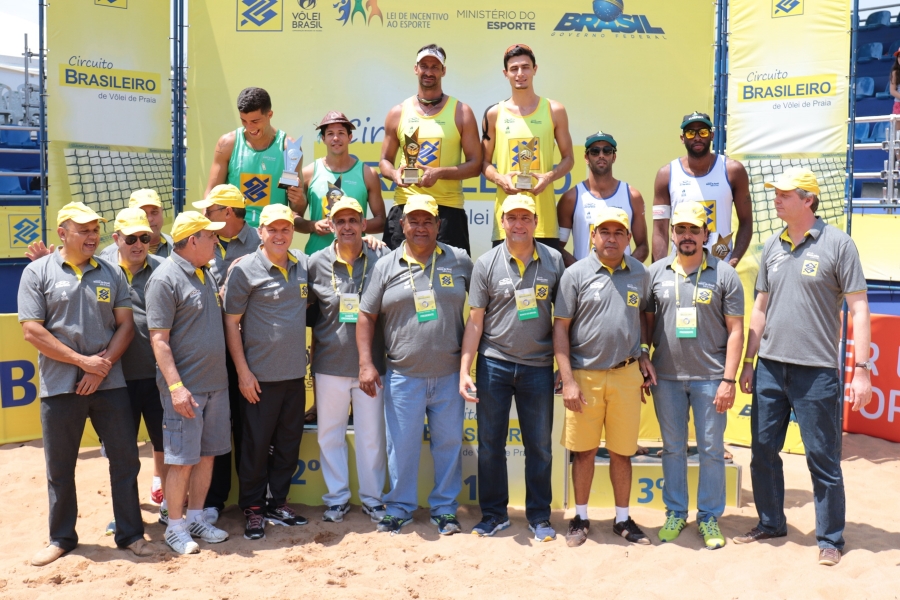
[476,354,553,523]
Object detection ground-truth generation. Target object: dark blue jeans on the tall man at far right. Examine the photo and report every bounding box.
[750,358,846,550]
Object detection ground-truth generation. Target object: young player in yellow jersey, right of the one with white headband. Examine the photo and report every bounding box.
[481,44,575,248]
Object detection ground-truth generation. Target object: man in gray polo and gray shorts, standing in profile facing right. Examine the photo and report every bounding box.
[145,211,231,554]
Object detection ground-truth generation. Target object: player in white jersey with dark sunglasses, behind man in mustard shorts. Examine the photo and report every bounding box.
[556,131,650,267]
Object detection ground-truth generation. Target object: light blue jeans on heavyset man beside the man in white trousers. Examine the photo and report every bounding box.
[384,369,465,519]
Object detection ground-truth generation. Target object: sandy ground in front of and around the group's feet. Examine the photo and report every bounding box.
[0,435,900,600]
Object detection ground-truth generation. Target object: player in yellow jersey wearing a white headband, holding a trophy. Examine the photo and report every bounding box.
[379,44,481,255]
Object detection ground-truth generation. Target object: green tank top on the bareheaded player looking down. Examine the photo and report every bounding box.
[228,127,287,227]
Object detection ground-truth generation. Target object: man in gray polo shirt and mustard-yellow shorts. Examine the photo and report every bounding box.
[553,207,656,546]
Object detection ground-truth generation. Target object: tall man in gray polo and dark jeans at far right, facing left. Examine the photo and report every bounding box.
[734,168,872,566]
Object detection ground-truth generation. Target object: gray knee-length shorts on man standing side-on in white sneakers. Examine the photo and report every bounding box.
[160,388,231,465]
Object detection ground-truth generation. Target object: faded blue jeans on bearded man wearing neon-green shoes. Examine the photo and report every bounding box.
[653,379,728,521]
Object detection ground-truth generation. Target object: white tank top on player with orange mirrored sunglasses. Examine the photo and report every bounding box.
[669,155,734,255]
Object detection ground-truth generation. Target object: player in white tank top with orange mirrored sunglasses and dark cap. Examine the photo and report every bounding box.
[653,112,753,267]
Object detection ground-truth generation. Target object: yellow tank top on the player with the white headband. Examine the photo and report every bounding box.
[394,97,463,208]
